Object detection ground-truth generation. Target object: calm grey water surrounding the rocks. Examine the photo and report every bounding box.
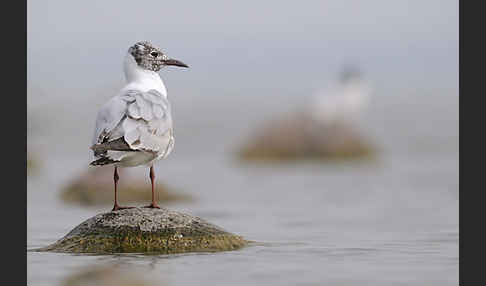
[27,88,459,286]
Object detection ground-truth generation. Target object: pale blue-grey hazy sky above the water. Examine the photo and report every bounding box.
[27,0,459,96]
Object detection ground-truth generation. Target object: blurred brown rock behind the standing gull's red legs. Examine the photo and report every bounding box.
[61,166,191,205]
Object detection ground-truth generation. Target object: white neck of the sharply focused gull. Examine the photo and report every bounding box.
[123,54,167,98]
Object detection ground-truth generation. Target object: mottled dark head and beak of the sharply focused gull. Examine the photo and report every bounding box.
[128,41,189,72]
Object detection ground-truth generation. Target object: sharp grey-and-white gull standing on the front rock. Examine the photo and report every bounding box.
[90,41,189,211]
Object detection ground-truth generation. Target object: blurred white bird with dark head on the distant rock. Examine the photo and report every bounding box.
[308,67,371,125]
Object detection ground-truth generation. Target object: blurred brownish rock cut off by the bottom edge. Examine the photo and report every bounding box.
[61,265,158,286]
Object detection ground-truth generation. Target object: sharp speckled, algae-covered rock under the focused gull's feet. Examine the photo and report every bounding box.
[38,208,247,254]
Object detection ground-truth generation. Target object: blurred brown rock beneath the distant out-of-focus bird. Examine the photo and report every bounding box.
[237,110,376,161]
